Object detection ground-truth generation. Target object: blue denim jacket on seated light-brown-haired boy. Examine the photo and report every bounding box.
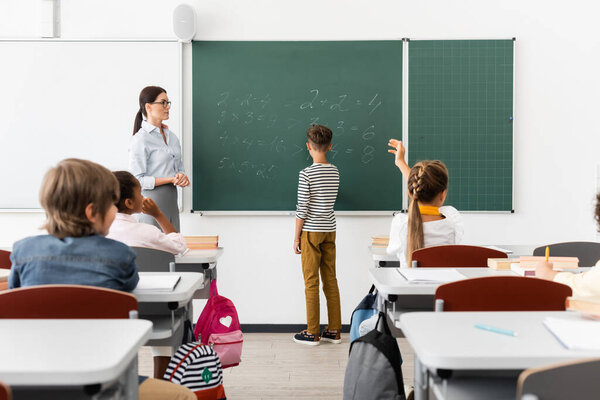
[8,235,139,292]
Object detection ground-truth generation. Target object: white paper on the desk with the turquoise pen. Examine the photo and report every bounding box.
[544,317,600,350]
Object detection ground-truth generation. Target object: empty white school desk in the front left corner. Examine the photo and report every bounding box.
[0,319,152,399]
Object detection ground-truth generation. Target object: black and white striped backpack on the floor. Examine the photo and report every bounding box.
[163,342,226,400]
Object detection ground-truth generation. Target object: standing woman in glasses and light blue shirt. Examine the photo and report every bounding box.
[129,86,190,232]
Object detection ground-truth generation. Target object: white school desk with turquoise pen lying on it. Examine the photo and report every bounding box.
[394,311,600,400]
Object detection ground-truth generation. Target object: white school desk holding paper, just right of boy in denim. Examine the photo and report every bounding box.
[132,272,204,350]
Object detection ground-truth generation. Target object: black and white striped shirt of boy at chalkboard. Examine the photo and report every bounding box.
[296,163,340,232]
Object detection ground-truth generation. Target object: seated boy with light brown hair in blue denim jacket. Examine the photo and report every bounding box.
[9,159,196,400]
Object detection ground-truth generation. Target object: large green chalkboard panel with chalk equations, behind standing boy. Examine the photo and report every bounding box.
[192,41,402,211]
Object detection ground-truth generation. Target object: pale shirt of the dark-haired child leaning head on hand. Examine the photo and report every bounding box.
[106,213,187,255]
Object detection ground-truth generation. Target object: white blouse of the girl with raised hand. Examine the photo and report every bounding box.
[387,206,464,268]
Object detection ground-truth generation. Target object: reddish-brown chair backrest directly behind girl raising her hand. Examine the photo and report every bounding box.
[412,245,507,268]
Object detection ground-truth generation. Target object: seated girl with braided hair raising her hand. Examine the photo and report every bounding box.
[387,139,463,268]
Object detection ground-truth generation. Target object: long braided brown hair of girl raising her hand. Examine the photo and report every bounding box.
[406,160,448,265]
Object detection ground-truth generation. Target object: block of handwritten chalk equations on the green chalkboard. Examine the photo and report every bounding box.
[214,88,383,180]
